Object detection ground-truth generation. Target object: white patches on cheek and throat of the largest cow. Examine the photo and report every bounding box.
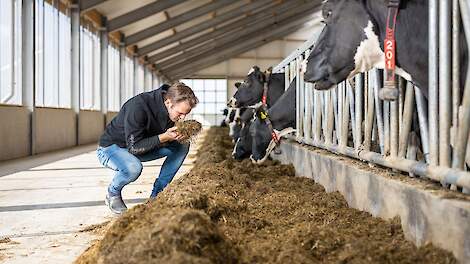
[348,20,412,81]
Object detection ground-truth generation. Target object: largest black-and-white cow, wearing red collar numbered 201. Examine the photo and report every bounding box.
[304,0,468,98]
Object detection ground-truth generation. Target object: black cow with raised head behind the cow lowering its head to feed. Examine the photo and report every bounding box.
[229,66,285,107]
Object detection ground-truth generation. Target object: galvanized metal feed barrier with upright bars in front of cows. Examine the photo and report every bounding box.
[273,0,470,193]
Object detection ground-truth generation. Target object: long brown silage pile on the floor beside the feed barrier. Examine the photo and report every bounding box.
[77,128,455,263]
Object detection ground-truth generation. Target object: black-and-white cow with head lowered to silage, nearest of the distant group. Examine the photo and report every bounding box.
[250,78,296,163]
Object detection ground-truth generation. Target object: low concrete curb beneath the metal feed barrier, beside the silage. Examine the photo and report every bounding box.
[272,141,470,263]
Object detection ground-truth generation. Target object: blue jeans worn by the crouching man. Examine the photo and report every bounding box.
[96,141,189,198]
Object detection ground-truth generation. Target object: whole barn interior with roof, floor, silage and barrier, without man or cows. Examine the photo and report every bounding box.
[0,0,470,263]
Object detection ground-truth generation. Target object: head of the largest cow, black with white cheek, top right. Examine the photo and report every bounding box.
[304,0,383,90]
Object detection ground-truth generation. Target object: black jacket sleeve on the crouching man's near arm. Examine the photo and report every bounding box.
[124,108,160,155]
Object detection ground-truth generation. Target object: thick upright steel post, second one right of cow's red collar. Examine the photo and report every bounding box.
[439,1,452,167]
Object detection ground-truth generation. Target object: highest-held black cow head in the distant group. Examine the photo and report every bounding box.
[233,66,266,107]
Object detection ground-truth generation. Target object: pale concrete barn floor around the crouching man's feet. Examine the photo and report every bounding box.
[0,136,202,263]
